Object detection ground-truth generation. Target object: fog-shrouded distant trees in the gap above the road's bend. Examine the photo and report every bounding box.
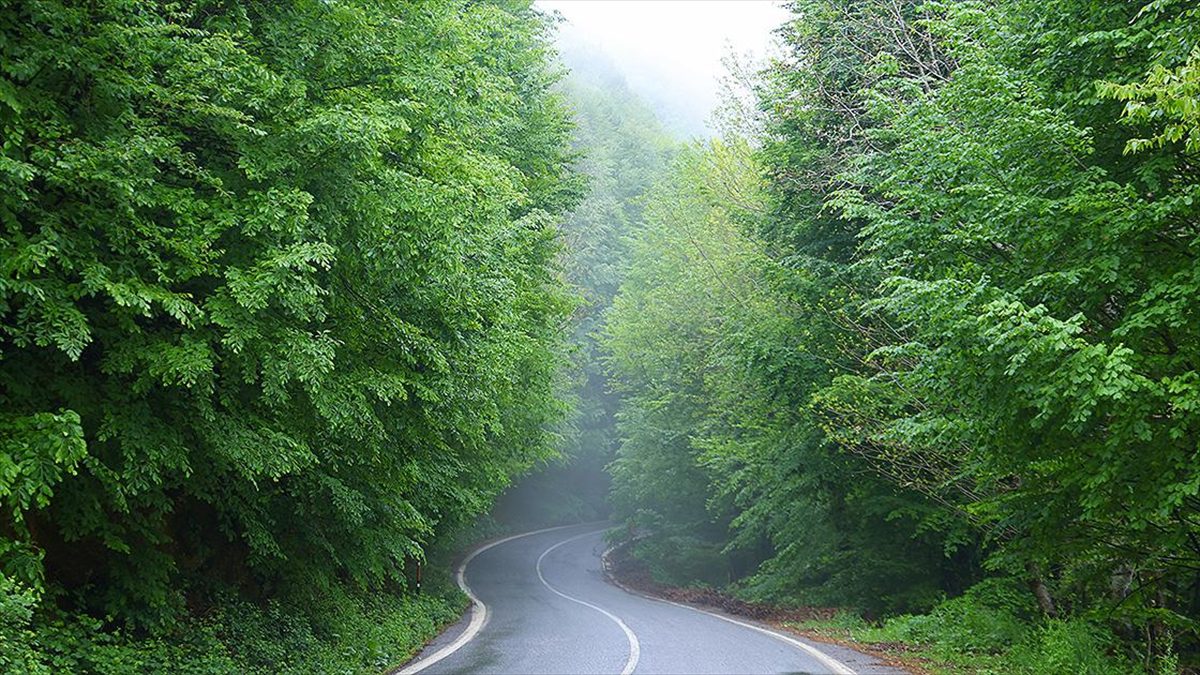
[494,47,671,526]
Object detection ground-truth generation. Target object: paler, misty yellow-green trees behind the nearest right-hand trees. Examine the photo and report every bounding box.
[607,142,970,611]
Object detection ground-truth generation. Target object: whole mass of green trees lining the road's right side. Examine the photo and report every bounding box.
[607,0,1200,671]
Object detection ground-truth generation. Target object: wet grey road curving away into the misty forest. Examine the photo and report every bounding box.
[392,524,854,675]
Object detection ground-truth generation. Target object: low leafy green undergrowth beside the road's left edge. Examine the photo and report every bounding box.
[0,566,466,675]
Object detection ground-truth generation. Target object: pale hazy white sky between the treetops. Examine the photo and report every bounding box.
[536,0,788,135]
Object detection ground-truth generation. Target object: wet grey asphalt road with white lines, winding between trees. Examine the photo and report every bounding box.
[404,525,895,675]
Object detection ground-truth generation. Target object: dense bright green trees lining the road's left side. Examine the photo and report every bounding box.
[0,0,582,670]
